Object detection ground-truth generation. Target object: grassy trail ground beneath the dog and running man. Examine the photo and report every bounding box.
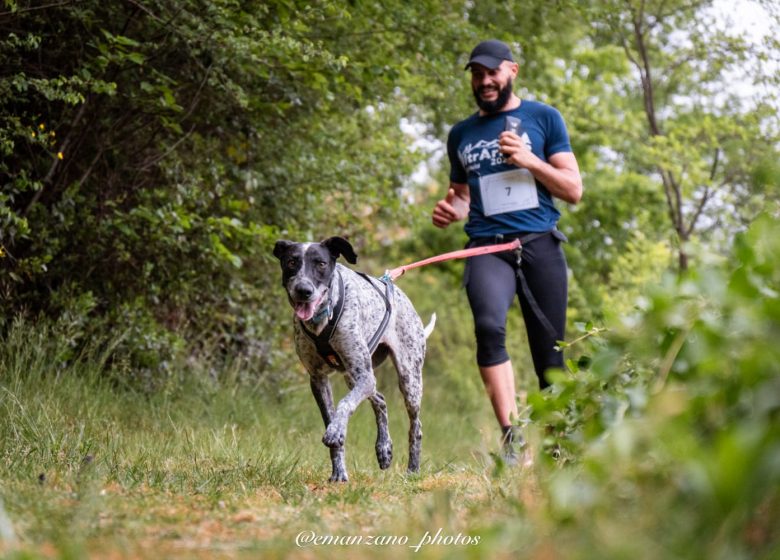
[0,320,546,558]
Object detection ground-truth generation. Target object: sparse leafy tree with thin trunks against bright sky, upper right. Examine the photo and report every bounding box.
[581,1,780,269]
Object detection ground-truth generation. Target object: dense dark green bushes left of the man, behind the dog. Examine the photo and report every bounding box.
[0,0,470,374]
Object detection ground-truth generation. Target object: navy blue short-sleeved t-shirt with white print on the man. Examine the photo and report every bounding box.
[447,100,572,239]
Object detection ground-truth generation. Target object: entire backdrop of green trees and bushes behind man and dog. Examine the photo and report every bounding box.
[0,0,778,379]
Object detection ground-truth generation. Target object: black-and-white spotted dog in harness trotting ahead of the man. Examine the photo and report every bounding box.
[274,237,435,482]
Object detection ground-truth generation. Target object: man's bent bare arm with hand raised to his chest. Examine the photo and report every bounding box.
[498,132,582,204]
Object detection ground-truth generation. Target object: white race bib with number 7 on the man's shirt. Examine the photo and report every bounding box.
[479,168,539,216]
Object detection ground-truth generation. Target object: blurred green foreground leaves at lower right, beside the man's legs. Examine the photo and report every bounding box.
[531,215,780,558]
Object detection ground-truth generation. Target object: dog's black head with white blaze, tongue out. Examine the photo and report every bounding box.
[274,237,357,321]
